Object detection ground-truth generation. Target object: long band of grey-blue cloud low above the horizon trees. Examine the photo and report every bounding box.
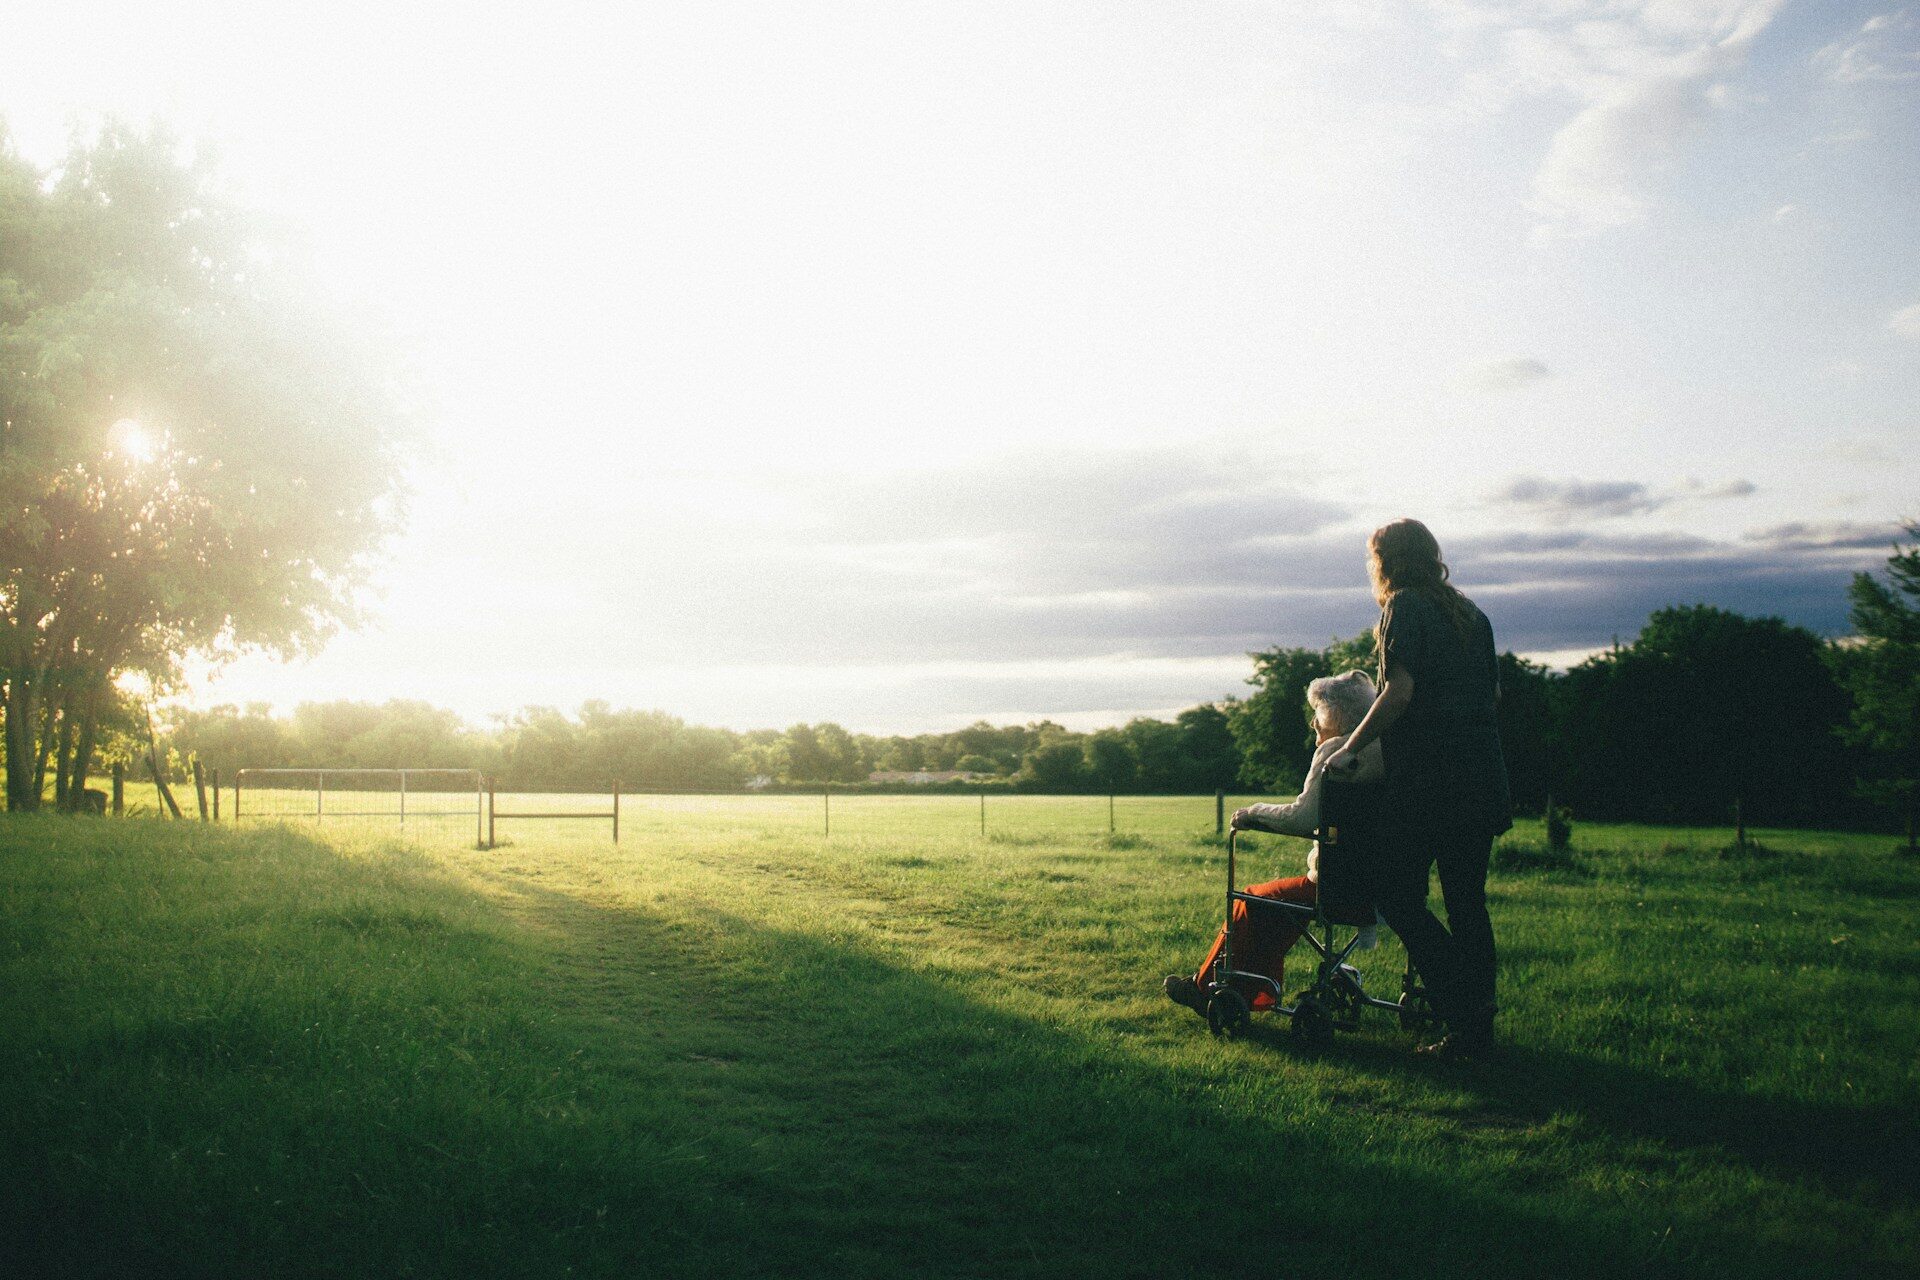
[507,451,1895,679]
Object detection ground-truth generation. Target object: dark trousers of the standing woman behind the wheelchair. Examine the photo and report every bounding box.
[1375,831,1494,1023]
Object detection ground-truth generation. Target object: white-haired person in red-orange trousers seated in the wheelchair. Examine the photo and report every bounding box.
[1164,672,1384,1017]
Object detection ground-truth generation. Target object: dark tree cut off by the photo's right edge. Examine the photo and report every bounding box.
[1834,524,1920,852]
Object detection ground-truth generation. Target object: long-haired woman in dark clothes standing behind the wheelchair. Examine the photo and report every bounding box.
[1165,520,1513,1055]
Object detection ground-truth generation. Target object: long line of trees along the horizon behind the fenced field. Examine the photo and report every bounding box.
[71,530,1920,831]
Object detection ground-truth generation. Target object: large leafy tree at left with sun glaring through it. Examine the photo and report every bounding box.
[0,125,401,810]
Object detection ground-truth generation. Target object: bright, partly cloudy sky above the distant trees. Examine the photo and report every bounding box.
[0,0,1920,733]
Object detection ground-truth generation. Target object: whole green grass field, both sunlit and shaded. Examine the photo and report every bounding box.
[0,796,1920,1278]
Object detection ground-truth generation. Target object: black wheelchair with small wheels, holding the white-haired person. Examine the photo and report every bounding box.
[1200,777,1438,1046]
